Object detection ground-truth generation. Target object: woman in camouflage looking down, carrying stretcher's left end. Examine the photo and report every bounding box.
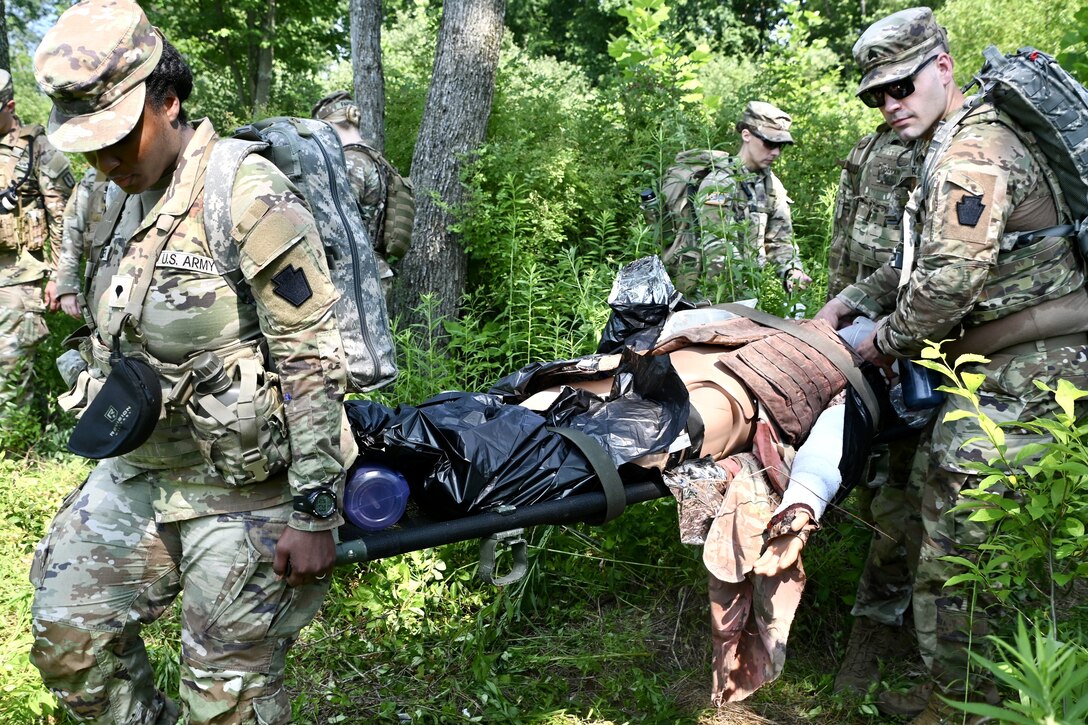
[30,0,356,724]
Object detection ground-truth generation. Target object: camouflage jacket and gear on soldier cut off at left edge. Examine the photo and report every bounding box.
[0,120,75,286]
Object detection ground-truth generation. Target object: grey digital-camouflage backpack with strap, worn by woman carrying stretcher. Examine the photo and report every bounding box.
[205,118,397,392]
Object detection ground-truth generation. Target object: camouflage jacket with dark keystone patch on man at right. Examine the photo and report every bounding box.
[857,106,1084,357]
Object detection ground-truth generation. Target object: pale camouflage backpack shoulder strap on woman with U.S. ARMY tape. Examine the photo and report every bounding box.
[203,138,268,304]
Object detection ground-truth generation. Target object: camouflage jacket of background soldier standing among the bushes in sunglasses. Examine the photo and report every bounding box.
[695,159,801,278]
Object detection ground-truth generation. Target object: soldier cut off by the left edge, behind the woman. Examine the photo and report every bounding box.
[0,69,74,429]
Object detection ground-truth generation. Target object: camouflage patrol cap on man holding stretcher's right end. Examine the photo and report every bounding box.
[854,8,948,93]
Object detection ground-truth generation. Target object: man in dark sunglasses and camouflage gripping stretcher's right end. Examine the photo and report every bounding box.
[819,8,1088,725]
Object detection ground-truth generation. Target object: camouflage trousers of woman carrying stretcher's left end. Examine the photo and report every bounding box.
[30,458,329,725]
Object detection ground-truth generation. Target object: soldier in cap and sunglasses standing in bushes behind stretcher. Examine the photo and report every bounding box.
[695,101,811,291]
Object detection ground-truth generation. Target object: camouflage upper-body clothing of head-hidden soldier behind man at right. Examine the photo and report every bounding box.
[827,124,917,299]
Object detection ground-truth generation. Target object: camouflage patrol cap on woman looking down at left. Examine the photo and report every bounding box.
[34,0,162,152]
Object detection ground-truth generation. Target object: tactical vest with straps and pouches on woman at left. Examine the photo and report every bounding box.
[73,142,292,476]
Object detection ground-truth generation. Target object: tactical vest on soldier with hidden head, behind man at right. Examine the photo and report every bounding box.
[836,130,917,274]
